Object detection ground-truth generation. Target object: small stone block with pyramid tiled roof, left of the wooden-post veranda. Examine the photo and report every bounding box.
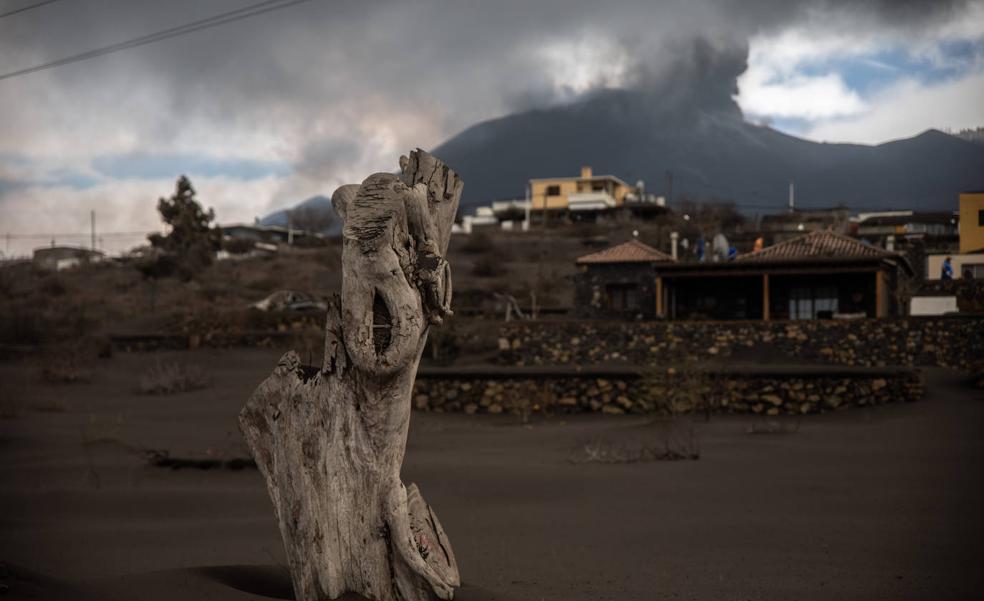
[574,239,674,319]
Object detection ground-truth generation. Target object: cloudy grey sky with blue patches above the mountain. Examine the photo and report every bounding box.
[0,0,984,255]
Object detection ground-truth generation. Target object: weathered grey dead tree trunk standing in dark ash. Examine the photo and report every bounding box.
[239,149,462,601]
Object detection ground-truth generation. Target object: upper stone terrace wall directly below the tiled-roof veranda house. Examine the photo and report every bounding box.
[499,316,984,370]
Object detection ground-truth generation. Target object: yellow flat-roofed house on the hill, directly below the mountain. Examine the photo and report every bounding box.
[530,166,633,213]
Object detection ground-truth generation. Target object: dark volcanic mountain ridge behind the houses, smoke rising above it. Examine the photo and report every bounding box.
[431,90,984,210]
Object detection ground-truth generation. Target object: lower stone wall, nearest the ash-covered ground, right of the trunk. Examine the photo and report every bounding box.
[414,369,923,415]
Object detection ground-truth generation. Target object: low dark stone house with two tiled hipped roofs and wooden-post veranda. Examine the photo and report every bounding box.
[575,231,912,320]
